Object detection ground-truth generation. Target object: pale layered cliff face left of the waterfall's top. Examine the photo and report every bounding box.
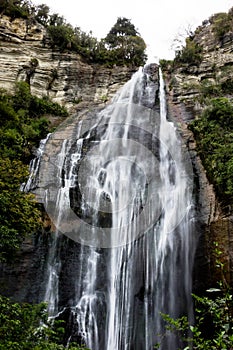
[0,16,137,112]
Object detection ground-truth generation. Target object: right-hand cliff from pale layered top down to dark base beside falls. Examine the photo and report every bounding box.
[165,15,233,290]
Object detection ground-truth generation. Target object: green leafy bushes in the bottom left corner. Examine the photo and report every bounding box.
[0,296,87,350]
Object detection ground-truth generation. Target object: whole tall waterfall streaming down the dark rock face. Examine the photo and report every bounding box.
[29,65,196,350]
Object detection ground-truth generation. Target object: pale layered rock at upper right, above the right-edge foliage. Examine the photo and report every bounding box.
[168,21,233,119]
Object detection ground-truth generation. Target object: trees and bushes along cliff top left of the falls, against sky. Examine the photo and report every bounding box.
[0,0,146,67]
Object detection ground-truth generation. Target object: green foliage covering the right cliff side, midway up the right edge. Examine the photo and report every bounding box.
[189,98,233,206]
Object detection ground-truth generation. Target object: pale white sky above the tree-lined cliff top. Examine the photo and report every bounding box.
[32,0,233,62]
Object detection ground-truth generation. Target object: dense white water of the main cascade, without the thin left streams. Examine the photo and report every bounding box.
[71,66,195,350]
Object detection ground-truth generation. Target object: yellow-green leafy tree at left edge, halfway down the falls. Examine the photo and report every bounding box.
[0,158,40,261]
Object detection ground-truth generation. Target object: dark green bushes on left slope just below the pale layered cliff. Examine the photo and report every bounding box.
[0,82,68,160]
